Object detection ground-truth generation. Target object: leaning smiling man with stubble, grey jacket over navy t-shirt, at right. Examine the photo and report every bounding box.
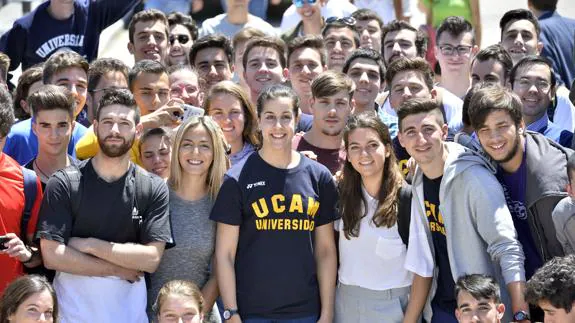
[469,86,572,322]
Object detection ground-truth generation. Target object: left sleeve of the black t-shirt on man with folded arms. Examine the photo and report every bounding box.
[36,172,74,243]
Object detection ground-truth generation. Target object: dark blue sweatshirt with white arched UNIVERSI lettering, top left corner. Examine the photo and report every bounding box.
[0,0,140,71]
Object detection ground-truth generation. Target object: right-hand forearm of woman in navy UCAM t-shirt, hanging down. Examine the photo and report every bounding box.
[315,243,337,322]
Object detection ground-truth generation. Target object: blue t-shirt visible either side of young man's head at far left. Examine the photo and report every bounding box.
[3,119,88,165]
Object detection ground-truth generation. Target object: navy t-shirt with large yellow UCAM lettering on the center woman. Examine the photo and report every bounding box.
[210,153,338,319]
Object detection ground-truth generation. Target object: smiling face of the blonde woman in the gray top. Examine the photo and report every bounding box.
[178,124,214,177]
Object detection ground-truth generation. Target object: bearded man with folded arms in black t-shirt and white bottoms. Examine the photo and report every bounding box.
[36,89,172,323]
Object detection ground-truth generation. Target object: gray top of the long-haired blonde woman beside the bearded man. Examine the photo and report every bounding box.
[148,189,220,322]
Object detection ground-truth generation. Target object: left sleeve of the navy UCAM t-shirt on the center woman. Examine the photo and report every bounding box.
[210,175,242,225]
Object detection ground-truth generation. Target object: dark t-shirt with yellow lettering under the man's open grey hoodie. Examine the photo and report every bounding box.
[423,175,456,313]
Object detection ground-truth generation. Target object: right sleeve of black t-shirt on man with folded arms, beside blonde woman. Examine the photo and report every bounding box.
[140,177,174,247]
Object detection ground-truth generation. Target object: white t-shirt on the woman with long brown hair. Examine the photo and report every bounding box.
[335,188,433,290]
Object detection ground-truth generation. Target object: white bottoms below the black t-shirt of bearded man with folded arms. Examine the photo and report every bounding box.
[54,272,149,323]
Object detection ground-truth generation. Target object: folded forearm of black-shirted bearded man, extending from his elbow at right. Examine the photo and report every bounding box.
[81,238,163,273]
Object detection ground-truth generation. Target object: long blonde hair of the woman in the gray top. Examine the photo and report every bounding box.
[168,116,230,200]
